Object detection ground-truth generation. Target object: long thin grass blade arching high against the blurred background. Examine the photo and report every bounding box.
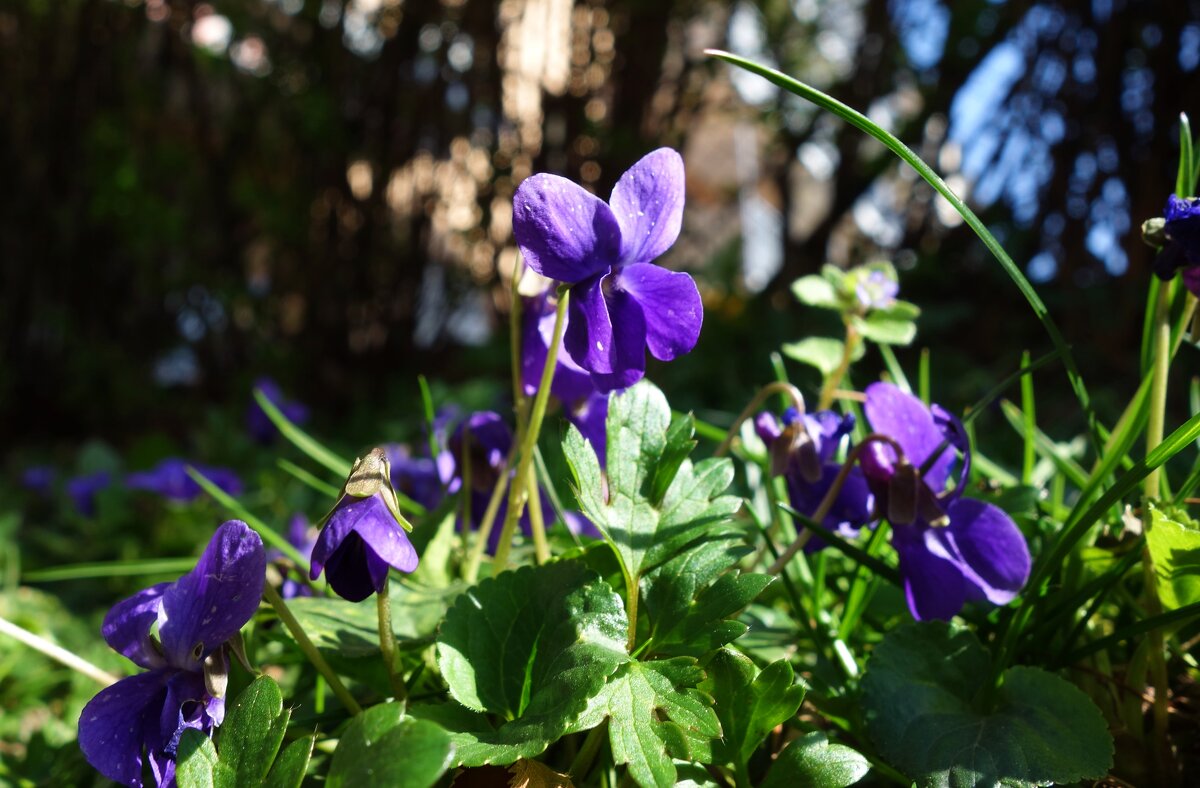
[704,49,1103,450]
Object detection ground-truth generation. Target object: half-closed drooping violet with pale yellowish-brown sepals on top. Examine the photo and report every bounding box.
[310,449,419,602]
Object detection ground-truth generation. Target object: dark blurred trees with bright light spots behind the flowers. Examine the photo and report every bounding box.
[0,0,1200,449]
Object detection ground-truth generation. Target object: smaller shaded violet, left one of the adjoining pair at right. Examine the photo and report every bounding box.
[755,408,875,552]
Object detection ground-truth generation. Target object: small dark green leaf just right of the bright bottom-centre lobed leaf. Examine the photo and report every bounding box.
[701,649,805,766]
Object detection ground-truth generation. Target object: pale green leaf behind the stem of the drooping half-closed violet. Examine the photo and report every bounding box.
[281,583,462,657]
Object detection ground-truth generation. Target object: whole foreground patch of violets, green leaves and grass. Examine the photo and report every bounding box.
[0,52,1200,787]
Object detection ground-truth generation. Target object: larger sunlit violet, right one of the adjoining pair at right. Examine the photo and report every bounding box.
[862,383,1030,620]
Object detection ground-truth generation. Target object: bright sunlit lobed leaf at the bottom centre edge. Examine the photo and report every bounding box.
[578,657,721,787]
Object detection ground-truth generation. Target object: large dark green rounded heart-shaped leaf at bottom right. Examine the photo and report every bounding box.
[862,622,1112,787]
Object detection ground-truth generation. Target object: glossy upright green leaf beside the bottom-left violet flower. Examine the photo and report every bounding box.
[176,676,313,788]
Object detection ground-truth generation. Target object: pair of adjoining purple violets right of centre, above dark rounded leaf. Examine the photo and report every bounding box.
[755,383,1030,620]
